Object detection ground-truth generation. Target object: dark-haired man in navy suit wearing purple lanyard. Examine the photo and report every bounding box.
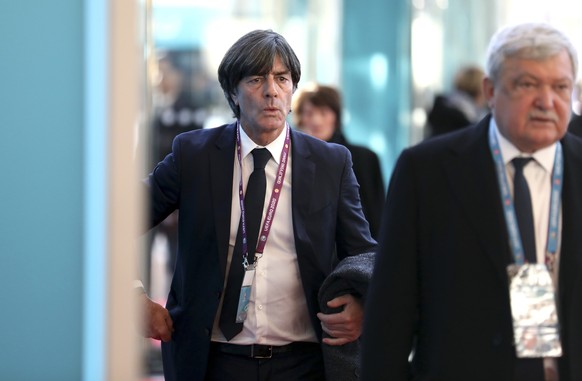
[143,30,376,381]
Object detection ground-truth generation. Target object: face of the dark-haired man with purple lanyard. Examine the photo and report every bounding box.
[232,56,294,143]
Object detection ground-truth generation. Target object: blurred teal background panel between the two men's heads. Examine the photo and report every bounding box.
[341,0,411,183]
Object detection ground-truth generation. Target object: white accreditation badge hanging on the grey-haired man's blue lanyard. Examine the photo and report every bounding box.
[508,263,562,358]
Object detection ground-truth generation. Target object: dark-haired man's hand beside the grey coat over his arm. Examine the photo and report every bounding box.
[317,294,364,345]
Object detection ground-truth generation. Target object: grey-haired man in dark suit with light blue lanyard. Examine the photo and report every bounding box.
[362,24,582,381]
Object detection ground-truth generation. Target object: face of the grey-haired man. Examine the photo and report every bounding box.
[483,50,574,152]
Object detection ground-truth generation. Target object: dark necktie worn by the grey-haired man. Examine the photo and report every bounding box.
[512,157,537,263]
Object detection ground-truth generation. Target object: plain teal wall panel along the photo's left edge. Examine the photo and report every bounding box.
[0,0,84,381]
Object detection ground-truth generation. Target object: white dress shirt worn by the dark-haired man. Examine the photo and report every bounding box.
[212,126,317,345]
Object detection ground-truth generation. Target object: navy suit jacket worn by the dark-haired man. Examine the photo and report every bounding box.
[147,124,376,381]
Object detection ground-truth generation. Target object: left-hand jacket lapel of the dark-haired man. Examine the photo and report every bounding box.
[209,123,236,277]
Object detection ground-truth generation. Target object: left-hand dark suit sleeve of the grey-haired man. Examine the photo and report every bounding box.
[362,151,419,381]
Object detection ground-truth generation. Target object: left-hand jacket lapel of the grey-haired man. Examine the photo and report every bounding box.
[444,118,510,282]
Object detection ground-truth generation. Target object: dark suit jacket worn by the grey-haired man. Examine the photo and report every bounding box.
[362,116,582,381]
